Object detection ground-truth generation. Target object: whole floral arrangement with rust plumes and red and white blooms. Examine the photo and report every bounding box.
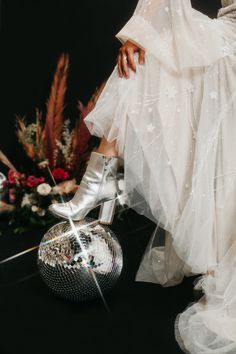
[0,54,104,233]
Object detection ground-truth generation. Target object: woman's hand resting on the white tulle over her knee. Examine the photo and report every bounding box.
[117,41,145,79]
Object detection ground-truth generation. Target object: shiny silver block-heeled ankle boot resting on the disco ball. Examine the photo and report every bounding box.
[49,151,124,225]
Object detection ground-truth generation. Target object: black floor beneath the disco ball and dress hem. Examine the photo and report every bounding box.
[0,210,194,354]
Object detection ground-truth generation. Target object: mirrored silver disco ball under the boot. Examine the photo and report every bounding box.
[38,218,123,301]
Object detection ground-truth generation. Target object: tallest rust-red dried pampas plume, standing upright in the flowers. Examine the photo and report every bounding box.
[45,54,69,167]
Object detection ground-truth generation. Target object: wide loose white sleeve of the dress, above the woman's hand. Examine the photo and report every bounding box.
[116,0,222,71]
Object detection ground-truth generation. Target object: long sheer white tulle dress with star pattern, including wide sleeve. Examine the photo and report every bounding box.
[85,0,236,354]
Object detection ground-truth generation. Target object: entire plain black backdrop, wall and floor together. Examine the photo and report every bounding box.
[0,0,220,354]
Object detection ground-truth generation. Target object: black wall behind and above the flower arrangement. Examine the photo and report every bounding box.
[0,0,220,166]
